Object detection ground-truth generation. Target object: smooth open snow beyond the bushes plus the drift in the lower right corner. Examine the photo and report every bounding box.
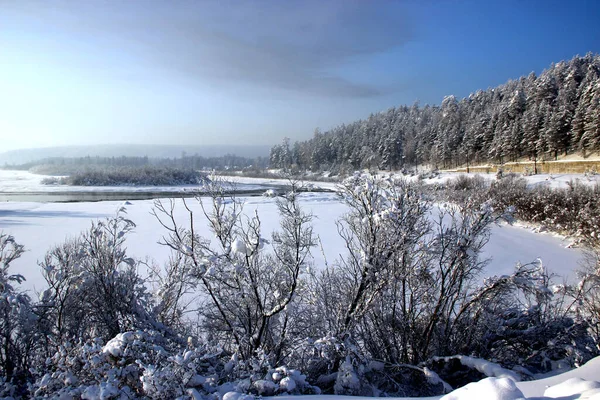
[0,171,600,400]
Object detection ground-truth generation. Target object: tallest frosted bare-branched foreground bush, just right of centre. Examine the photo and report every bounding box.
[292,174,520,394]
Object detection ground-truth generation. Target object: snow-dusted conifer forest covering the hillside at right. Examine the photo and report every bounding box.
[270,54,600,171]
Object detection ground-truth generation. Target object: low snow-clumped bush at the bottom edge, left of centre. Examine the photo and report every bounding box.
[30,331,226,399]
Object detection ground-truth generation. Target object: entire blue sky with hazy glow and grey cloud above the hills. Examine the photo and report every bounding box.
[0,0,600,151]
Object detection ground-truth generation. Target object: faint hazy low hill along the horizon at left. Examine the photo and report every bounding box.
[0,144,270,165]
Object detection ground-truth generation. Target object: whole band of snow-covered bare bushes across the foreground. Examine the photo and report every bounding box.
[0,174,600,400]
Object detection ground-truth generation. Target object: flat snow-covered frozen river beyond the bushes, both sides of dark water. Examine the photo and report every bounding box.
[0,171,583,296]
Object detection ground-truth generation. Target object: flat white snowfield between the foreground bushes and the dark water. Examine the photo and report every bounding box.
[0,193,583,291]
